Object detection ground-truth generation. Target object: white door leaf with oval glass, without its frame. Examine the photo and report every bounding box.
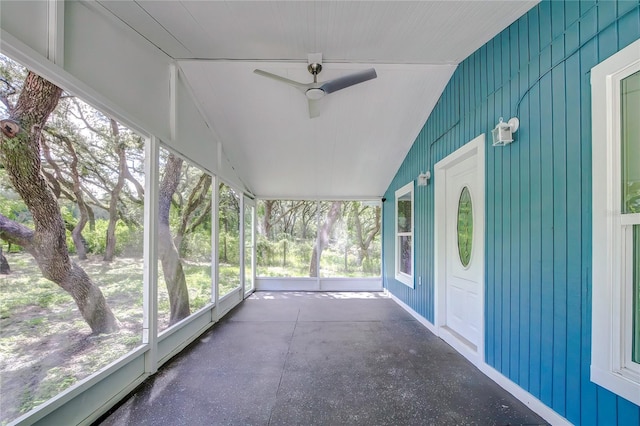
[445,157,481,347]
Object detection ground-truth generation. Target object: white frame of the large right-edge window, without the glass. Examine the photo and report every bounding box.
[591,40,640,405]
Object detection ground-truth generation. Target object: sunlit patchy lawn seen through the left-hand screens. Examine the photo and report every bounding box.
[0,253,239,424]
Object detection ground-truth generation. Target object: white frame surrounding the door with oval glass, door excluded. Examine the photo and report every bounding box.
[434,133,485,366]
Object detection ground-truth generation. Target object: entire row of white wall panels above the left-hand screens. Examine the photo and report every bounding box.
[0,0,243,188]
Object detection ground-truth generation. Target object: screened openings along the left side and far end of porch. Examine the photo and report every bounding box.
[0,51,382,424]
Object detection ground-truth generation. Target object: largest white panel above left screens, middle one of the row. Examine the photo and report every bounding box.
[65,2,171,140]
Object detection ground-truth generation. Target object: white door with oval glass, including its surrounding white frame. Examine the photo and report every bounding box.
[434,135,484,361]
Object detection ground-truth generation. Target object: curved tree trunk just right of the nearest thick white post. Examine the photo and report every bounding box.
[158,154,191,325]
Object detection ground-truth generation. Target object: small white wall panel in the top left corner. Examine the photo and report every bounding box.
[0,0,49,57]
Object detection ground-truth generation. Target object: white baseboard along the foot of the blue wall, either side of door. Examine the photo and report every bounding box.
[387,291,571,426]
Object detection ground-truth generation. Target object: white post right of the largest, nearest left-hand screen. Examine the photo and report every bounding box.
[142,137,160,374]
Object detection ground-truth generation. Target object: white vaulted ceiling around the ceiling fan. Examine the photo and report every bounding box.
[99,0,538,199]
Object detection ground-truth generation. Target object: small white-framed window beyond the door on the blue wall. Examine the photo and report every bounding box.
[396,181,413,288]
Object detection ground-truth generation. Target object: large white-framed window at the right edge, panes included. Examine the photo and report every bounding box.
[591,41,640,404]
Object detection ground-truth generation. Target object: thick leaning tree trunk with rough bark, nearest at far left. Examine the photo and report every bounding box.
[0,72,119,334]
